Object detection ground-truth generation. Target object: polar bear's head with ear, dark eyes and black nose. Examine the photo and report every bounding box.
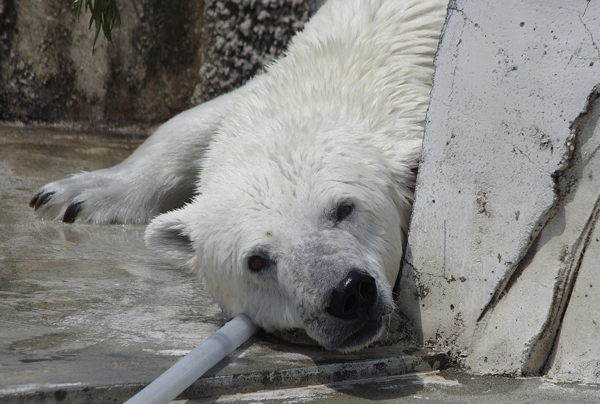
[146,102,420,351]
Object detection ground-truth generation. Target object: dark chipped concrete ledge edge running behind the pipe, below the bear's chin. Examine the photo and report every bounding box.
[0,351,451,404]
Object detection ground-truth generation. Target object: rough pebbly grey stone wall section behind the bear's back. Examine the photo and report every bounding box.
[194,0,320,103]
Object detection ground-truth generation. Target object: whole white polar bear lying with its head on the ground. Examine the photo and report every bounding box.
[30,0,446,351]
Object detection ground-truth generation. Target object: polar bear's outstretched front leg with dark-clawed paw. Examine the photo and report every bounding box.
[29,90,240,223]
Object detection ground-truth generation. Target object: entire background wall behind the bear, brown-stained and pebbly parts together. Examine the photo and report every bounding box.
[0,0,319,129]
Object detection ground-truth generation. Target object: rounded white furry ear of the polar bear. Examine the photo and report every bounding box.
[145,209,195,266]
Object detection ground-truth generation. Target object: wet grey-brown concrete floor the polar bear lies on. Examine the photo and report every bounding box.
[0,127,445,403]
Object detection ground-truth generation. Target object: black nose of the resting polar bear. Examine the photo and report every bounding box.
[327,269,377,320]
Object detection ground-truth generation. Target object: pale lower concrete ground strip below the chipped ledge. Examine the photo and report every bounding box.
[171,370,600,404]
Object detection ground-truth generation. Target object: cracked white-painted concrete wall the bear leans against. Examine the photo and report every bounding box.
[399,0,600,382]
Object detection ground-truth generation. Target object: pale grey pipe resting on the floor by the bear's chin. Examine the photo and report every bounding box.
[125,314,258,404]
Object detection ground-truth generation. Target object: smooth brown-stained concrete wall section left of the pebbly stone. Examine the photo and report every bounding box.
[0,0,203,127]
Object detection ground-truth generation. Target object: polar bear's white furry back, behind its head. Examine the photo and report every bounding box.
[223,0,446,144]
